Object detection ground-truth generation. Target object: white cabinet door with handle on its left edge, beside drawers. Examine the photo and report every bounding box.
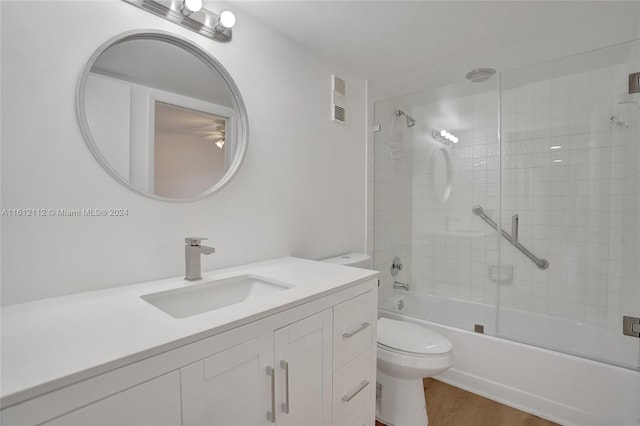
[274,309,333,426]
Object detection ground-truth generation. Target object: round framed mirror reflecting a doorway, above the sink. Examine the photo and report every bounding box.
[77,32,248,202]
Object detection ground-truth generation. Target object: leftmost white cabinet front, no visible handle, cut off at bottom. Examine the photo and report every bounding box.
[43,371,180,426]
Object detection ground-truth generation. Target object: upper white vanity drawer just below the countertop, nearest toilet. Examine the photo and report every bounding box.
[333,291,377,370]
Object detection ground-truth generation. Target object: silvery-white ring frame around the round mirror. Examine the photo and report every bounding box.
[76,30,249,203]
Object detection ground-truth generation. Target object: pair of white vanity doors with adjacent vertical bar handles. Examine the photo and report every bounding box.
[180,309,332,426]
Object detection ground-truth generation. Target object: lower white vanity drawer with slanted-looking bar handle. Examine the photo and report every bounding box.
[333,350,375,425]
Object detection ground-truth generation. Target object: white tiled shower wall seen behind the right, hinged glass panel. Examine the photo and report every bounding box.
[500,62,630,327]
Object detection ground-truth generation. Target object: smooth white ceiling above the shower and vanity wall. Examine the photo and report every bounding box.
[229,0,640,96]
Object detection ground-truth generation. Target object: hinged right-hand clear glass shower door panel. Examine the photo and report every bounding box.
[498,41,640,368]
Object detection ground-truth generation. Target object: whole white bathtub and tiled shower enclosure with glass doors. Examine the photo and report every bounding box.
[370,40,640,425]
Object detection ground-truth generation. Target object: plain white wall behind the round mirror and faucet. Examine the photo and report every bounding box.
[1,0,366,305]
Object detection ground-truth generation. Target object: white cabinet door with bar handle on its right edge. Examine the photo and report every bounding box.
[180,333,273,426]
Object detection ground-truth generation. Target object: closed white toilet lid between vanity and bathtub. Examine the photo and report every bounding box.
[378,318,452,355]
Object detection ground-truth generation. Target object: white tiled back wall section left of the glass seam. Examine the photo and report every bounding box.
[411,90,500,304]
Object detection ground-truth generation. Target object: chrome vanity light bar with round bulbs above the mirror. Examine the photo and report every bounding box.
[122,0,236,43]
